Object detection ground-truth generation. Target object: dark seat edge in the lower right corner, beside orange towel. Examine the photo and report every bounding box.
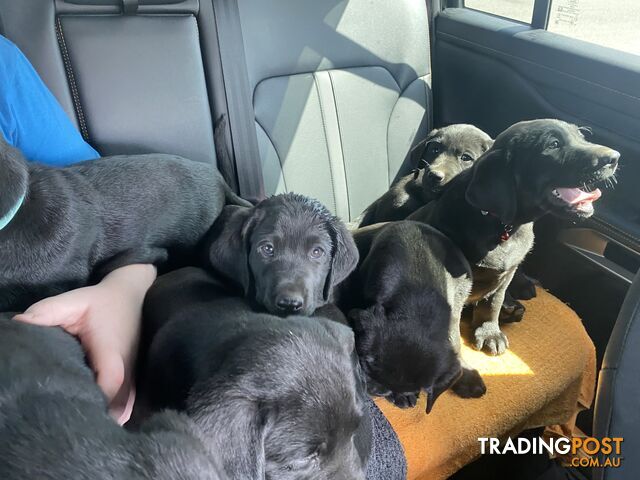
[593,273,640,480]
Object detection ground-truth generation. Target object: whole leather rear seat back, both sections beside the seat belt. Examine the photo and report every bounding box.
[0,0,431,220]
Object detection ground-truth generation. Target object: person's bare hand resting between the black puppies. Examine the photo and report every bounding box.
[15,265,156,424]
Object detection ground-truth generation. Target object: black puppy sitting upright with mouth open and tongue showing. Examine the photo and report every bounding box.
[409,119,620,355]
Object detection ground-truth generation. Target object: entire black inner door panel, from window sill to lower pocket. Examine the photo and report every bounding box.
[433,8,640,402]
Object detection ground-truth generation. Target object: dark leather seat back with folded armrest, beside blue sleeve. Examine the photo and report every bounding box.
[0,0,222,169]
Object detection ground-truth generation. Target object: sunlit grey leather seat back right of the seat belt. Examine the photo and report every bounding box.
[232,0,431,220]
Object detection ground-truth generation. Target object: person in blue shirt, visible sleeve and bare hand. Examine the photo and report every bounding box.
[0,36,156,420]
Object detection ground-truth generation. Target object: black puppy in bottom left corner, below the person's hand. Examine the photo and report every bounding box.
[0,314,226,480]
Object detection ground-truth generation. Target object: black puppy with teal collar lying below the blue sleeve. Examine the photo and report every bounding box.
[0,136,250,311]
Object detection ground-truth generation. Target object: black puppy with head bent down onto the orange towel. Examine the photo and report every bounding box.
[340,220,486,404]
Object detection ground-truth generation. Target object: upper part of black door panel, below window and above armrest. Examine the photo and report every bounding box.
[434,8,640,262]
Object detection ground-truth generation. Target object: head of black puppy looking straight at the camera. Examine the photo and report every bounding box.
[204,193,358,315]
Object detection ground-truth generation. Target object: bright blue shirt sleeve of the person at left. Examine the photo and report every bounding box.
[0,36,99,166]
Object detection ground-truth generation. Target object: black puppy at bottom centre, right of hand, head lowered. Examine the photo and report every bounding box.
[142,268,370,480]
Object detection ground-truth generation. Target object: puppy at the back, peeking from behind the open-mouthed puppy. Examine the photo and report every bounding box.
[359,124,493,227]
